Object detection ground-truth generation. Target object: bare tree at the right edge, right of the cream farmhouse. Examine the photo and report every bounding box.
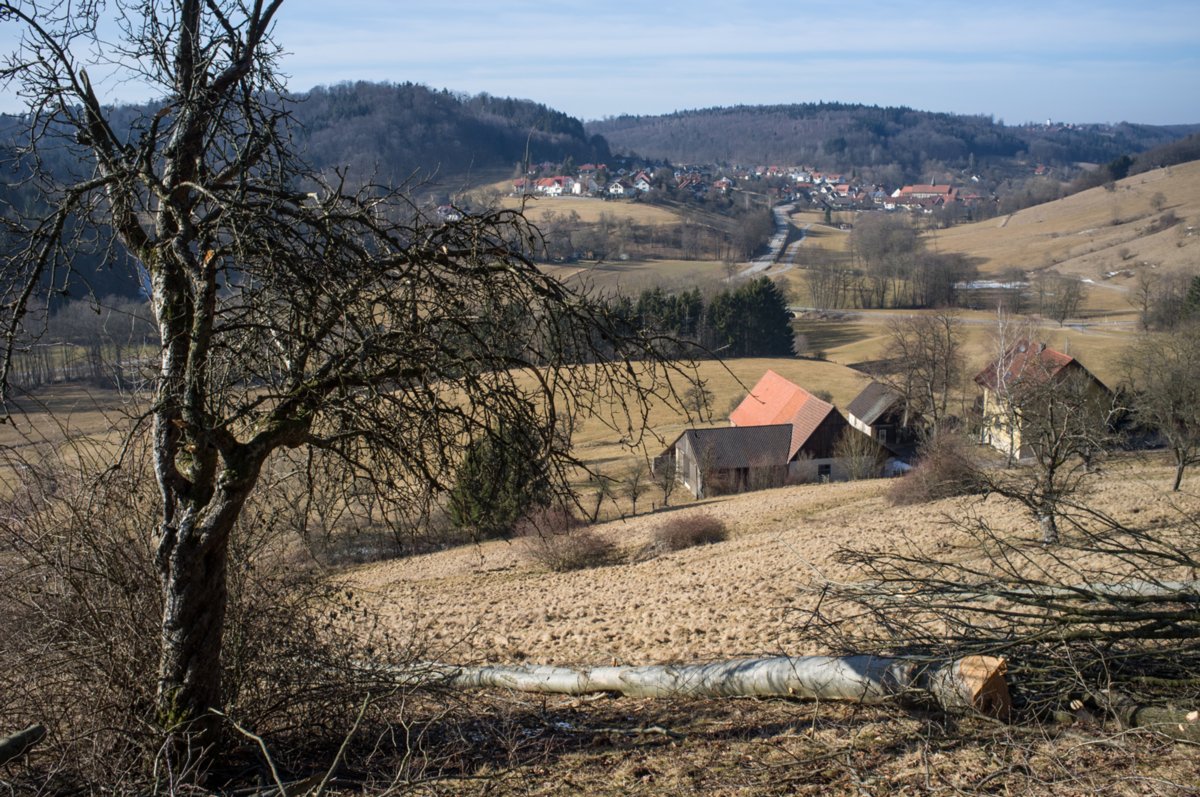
[1124,322,1200,491]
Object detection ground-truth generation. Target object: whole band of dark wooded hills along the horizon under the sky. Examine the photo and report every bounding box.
[0,82,1200,302]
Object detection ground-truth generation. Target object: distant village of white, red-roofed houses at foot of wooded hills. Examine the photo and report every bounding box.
[512,163,985,212]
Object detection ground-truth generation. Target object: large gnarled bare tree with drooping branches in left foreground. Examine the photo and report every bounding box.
[0,0,696,772]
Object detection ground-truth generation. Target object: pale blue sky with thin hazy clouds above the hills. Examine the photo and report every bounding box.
[0,0,1200,125]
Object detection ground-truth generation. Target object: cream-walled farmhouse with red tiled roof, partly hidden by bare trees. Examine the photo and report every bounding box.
[974,340,1110,457]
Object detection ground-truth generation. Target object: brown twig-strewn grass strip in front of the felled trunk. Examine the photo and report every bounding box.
[405,694,1189,797]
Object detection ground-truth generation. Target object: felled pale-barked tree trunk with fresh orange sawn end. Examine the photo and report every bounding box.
[405,655,1012,719]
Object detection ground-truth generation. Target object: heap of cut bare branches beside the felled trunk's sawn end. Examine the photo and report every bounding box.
[808,502,1200,717]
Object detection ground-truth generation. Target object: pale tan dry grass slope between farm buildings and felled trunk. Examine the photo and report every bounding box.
[347,459,1200,665]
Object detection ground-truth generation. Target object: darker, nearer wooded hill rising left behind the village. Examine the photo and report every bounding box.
[0,82,610,296]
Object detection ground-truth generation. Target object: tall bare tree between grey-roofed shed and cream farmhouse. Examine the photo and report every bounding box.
[882,311,962,435]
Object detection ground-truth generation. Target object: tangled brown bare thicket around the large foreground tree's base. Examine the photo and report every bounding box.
[0,441,422,793]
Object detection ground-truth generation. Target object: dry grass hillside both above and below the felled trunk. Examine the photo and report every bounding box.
[348,451,1200,797]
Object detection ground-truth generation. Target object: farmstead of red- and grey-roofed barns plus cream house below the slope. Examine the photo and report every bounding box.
[654,341,1108,498]
